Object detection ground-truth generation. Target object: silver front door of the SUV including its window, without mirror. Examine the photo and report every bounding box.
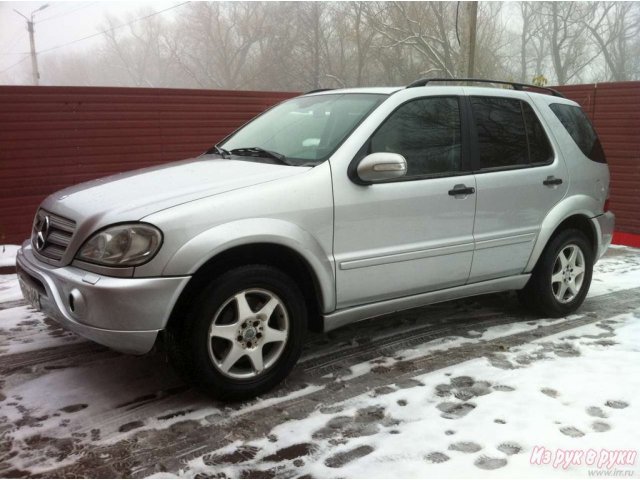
[332,96,476,308]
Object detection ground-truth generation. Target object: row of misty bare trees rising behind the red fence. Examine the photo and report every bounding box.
[2,1,640,91]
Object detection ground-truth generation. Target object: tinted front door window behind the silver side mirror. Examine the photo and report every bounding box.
[369,97,462,176]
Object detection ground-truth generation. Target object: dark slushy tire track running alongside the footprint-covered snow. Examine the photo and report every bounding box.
[36,288,640,477]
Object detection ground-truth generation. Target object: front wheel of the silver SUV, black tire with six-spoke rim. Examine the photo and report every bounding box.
[167,265,307,400]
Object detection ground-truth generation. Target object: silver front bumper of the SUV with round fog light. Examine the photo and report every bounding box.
[16,241,190,354]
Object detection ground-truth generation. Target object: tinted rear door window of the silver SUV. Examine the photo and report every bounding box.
[471,97,553,169]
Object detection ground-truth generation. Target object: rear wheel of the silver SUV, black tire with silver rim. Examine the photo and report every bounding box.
[518,229,593,317]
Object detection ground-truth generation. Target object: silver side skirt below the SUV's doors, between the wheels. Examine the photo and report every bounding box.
[323,274,531,332]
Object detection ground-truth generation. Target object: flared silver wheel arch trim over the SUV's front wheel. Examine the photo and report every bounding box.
[162,218,336,312]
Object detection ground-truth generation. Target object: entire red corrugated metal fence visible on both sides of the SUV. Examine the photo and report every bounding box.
[0,82,640,244]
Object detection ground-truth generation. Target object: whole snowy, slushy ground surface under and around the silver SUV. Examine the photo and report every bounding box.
[0,248,640,478]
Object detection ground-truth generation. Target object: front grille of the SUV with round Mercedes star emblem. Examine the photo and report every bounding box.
[31,209,76,261]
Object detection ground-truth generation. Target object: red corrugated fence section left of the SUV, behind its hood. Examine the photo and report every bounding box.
[0,86,294,245]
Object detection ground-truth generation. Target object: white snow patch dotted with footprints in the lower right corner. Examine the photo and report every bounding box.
[179,309,640,478]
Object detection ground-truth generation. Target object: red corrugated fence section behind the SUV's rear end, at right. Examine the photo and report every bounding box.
[555,82,640,234]
